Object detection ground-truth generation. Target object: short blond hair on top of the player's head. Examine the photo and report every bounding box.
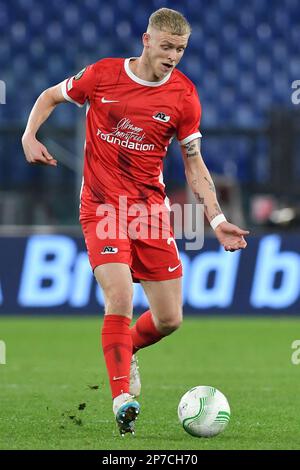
[147,8,192,36]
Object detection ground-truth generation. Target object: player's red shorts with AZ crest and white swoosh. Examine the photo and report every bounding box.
[80,203,182,282]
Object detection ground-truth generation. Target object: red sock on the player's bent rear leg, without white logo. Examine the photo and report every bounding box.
[130,310,165,354]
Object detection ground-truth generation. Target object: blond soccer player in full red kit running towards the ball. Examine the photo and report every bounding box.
[22,8,249,435]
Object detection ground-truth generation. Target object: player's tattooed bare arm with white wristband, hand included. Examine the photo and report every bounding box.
[181,138,249,251]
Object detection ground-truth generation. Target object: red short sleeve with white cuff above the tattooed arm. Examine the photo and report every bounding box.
[176,87,202,145]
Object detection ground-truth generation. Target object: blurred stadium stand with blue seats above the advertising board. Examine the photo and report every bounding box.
[0,0,300,225]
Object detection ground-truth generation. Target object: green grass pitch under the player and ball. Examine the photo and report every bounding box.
[0,317,300,450]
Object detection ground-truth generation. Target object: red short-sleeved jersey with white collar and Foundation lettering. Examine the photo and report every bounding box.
[62,58,201,211]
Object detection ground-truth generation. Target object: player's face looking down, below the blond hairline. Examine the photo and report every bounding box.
[144,30,189,80]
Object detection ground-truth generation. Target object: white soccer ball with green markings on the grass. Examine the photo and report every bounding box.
[178,385,230,437]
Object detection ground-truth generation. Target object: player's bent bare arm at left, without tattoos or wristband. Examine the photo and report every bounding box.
[22,83,66,166]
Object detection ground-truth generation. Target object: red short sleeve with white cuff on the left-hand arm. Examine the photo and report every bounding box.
[62,64,96,107]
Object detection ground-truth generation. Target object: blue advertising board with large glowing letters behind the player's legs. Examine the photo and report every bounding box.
[0,234,300,315]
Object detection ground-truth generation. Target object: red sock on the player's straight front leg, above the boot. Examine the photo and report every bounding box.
[102,315,132,398]
